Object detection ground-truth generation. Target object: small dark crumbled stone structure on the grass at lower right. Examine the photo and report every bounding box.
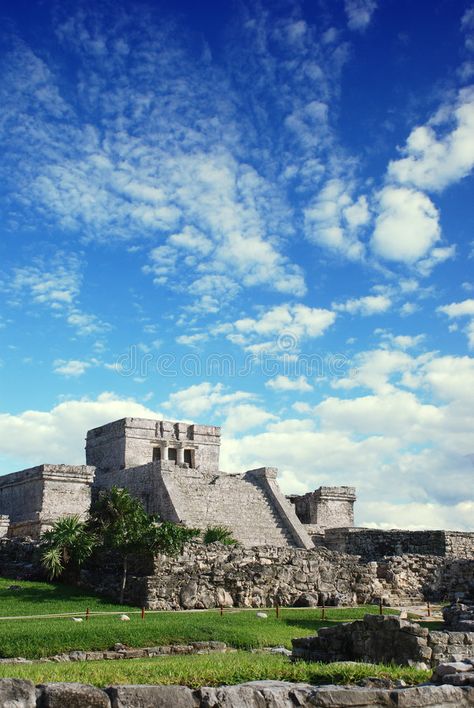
[292,615,474,666]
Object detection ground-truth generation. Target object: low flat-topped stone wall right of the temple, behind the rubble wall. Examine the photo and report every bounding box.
[318,528,474,560]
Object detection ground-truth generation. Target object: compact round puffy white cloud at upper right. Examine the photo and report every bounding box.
[371,186,441,264]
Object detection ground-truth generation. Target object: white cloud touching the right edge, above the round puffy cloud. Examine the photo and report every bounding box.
[388,87,474,190]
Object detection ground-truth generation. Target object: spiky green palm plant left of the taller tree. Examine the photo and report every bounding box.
[41,515,97,580]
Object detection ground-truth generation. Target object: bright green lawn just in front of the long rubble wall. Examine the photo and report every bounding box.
[0,580,394,659]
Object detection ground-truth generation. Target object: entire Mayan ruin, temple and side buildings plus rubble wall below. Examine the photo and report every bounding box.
[0,418,474,609]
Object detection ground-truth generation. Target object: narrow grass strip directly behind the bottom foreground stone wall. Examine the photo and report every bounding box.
[0,652,430,688]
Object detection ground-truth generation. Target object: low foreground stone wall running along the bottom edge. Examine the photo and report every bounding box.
[0,679,474,708]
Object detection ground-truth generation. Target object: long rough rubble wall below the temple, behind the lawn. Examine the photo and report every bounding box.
[81,543,474,609]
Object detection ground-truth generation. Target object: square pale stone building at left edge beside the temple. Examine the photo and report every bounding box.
[0,464,94,537]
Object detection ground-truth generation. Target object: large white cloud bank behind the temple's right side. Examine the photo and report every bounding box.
[222,352,474,529]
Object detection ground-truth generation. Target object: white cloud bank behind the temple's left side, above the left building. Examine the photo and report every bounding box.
[0,393,161,472]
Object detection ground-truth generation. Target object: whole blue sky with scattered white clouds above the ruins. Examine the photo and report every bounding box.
[0,0,474,529]
